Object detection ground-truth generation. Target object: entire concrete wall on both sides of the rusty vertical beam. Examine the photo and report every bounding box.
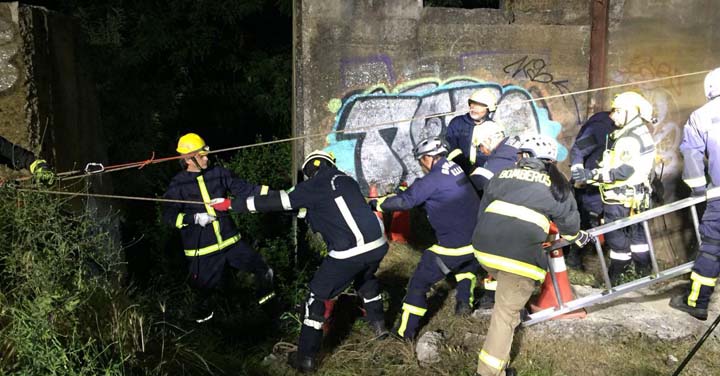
[295,0,720,261]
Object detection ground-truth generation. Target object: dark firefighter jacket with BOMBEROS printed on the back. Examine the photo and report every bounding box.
[473,158,580,280]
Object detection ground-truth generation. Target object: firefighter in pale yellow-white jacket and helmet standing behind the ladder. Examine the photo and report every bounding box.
[572,91,655,284]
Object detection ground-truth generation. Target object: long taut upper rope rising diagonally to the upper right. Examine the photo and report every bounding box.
[15,70,710,181]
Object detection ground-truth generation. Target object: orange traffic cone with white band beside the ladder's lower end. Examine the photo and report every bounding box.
[530,249,587,319]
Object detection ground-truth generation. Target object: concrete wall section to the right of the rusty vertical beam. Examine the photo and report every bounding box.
[607,0,720,263]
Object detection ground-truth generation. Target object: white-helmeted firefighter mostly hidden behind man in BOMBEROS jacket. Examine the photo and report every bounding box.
[470,122,520,309]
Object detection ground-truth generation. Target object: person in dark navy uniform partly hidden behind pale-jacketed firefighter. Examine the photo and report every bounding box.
[565,111,614,269]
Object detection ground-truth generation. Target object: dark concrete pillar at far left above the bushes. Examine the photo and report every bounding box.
[0,3,112,223]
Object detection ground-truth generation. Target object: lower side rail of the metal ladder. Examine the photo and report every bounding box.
[522,261,695,326]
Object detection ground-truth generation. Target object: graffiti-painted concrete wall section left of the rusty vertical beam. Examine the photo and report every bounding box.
[296,0,590,194]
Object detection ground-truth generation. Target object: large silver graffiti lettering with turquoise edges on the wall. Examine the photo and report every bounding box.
[325,77,567,194]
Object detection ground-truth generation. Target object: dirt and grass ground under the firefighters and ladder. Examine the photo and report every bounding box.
[267,243,720,376]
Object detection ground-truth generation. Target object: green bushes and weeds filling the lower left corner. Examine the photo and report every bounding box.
[0,188,217,375]
